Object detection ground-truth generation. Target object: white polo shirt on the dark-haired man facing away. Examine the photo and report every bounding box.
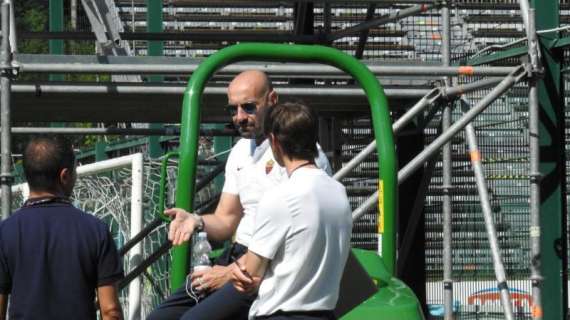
[248,167,352,319]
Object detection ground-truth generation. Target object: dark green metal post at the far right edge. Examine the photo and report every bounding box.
[531,0,568,320]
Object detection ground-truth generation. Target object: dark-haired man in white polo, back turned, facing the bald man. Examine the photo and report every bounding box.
[232,103,352,319]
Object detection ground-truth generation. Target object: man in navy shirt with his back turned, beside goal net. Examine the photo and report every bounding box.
[0,136,123,320]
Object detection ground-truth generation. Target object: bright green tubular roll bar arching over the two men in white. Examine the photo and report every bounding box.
[171,43,397,290]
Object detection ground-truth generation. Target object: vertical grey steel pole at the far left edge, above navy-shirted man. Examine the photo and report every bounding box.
[0,0,12,219]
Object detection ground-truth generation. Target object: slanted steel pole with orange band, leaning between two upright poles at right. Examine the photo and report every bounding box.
[461,99,514,320]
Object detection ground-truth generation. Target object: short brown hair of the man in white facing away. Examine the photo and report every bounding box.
[263,102,318,161]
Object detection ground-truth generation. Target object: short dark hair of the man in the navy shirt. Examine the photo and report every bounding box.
[24,135,75,191]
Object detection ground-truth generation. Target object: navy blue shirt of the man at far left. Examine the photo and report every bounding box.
[0,203,123,319]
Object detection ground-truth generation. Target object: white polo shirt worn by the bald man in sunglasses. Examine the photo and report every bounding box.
[222,139,332,246]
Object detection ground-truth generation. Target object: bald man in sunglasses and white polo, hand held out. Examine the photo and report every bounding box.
[147,70,331,320]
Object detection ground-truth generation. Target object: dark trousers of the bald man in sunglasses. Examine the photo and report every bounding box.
[147,243,256,320]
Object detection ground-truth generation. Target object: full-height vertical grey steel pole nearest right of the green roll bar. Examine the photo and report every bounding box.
[441,1,453,320]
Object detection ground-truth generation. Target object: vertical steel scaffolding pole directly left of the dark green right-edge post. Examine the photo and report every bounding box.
[521,9,542,319]
